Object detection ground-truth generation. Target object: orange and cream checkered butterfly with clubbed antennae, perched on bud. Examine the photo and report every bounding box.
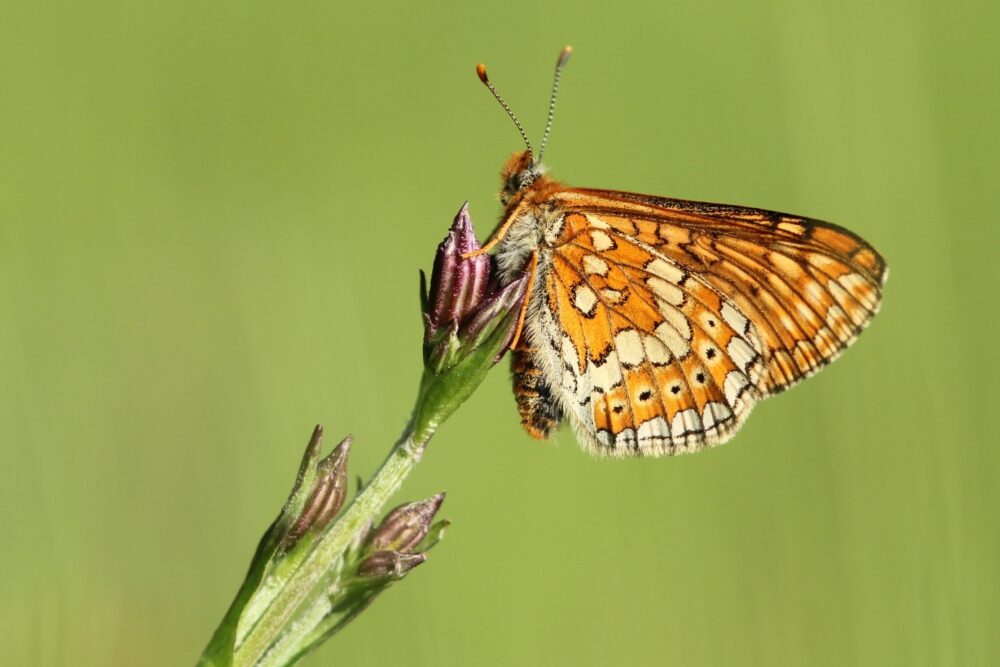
[464,47,888,457]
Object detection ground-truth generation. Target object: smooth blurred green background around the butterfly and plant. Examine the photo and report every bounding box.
[0,0,1000,666]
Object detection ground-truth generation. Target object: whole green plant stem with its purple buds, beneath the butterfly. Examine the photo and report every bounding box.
[199,206,528,667]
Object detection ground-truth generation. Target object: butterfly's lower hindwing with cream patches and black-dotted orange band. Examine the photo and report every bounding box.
[529,213,765,456]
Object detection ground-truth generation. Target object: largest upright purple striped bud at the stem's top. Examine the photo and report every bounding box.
[424,202,490,340]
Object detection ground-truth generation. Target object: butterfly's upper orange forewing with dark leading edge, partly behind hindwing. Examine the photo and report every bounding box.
[556,189,888,394]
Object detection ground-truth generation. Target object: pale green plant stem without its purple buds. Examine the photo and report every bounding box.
[199,312,516,667]
